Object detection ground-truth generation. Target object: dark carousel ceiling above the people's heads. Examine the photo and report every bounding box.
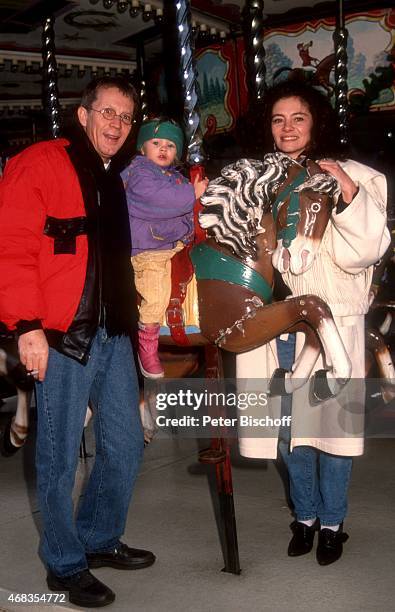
[0,0,386,112]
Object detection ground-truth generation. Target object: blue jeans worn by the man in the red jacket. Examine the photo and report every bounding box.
[36,328,144,576]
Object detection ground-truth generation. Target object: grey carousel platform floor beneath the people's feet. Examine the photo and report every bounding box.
[0,396,395,612]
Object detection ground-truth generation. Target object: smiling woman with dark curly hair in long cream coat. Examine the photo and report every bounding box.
[237,80,390,565]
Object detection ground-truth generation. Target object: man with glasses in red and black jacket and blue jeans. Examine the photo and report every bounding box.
[0,77,155,607]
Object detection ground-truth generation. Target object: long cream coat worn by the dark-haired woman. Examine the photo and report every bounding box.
[236,160,391,459]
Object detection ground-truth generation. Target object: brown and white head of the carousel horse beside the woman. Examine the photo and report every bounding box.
[273,160,339,274]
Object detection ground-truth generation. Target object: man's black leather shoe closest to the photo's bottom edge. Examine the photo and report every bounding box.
[47,570,115,608]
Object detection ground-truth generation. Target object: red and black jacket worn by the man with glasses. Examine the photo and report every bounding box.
[0,128,136,363]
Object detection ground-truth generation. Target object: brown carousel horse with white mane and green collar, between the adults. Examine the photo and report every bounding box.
[191,153,351,401]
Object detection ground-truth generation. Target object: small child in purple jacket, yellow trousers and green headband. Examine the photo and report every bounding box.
[122,119,208,378]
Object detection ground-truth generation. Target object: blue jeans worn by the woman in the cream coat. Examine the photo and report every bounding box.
[277,334,352,526]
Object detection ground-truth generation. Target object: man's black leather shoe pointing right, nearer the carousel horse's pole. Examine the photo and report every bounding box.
[86,542,155,569]
